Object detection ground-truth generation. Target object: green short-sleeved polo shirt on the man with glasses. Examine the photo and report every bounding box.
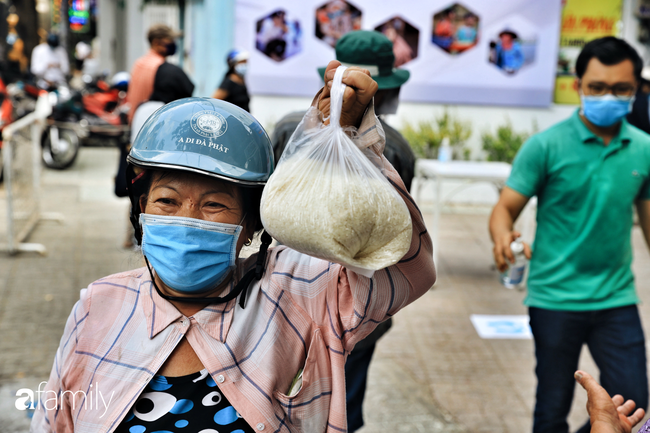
[506,111,650,311]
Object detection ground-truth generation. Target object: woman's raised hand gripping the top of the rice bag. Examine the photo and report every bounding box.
[318,60,378,128]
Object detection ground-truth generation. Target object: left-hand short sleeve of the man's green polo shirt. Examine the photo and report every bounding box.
[506,135,547,197]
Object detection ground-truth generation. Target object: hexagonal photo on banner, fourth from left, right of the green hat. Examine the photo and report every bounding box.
[431,3,480,54]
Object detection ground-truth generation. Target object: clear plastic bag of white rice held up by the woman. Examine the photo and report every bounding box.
[260,66,412,275]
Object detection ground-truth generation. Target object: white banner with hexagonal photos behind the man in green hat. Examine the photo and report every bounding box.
[235,0,562,107]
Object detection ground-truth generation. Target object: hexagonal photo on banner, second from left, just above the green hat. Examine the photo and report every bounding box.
[316,0,362,48]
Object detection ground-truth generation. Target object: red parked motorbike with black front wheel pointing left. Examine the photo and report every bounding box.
[41,73,129,170]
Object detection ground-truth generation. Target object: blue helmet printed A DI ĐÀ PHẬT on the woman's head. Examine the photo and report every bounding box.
[126,97,273,242]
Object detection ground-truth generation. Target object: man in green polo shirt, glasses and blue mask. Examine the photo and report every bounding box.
[490,37,650,433]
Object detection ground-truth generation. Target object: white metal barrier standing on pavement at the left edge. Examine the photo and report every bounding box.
[0,93,63,254]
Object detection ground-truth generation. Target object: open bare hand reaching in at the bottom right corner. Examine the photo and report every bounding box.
[574,370,645,433]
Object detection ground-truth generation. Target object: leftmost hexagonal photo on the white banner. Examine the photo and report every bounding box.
[255,9,302,62]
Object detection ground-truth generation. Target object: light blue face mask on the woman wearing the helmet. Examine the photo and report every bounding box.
[140,214,242,294]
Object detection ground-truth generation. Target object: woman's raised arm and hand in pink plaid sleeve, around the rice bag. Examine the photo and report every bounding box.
[273,61,436,351]
